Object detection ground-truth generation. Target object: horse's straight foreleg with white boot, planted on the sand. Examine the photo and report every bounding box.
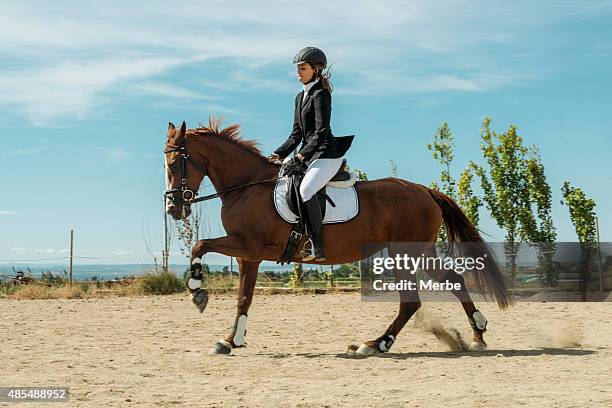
[210,258,260,354]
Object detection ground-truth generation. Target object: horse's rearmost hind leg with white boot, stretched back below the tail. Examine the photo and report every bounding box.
[425,247,487,351]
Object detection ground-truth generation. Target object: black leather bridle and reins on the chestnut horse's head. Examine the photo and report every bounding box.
[164,141,278,206]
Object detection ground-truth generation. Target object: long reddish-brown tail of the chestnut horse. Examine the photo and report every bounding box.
[429,189,514,309]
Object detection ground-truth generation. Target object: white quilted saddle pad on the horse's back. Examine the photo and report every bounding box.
[273,177,359,224]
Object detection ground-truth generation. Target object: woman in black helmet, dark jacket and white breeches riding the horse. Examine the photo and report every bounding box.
[268,47,353,262]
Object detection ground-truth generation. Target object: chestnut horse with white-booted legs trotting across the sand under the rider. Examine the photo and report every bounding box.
[165,118,513,355]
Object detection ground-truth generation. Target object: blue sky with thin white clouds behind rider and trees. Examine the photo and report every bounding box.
[0,1,612,263]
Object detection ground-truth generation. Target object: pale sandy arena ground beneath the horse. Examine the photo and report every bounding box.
[0,293,612,408]
